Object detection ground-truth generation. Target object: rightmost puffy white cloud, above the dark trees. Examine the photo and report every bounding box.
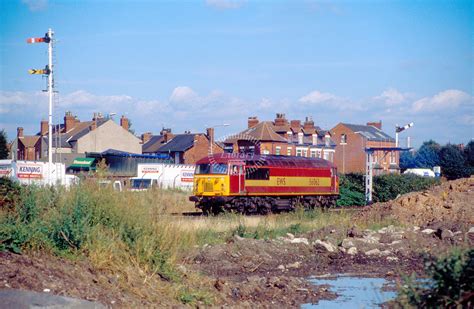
[412,89,473,112]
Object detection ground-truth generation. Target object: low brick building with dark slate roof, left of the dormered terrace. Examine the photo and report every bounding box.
[154,128,224,164]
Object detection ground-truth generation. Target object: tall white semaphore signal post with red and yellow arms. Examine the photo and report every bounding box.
[26,28,54,184]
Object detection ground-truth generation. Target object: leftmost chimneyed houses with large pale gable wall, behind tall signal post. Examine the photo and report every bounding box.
[12,112,141,164]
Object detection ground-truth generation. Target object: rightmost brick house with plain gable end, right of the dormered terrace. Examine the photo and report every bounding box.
[331,121,400,175]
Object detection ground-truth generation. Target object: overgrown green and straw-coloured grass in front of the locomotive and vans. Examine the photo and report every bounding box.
[0,181,400,305]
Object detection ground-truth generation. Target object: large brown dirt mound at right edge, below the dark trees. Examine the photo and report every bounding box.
[362,177,474,230]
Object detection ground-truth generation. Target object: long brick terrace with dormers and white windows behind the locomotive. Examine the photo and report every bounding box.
[224,114,336,161]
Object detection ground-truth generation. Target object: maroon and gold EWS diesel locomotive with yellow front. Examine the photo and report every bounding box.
[189,153,339,214]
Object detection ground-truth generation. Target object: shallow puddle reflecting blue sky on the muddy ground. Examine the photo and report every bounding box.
[301,276,397,309]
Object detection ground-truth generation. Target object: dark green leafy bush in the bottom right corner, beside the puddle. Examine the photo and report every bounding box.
[397,248,474,308]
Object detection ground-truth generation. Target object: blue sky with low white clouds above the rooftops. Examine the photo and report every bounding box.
[0,0,474,146]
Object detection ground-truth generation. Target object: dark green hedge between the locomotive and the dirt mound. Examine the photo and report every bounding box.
[337,174,439,206]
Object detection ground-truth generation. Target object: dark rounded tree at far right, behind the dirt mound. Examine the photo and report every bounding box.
[439,144,470,180]
